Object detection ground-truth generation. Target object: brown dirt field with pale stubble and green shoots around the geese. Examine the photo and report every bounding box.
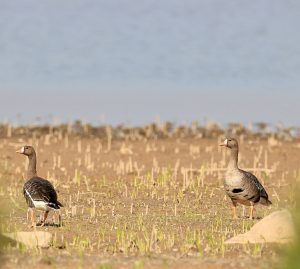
[0,135,300,269]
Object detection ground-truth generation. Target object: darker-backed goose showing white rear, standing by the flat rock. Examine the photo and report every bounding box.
[17,146,63,227]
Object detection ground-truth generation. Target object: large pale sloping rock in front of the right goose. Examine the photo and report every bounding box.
[225,209,295,244]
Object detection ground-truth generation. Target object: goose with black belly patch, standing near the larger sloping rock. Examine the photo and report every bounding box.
[220,138,272,219]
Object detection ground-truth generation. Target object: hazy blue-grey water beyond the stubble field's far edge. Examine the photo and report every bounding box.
[0,0,300,126]
